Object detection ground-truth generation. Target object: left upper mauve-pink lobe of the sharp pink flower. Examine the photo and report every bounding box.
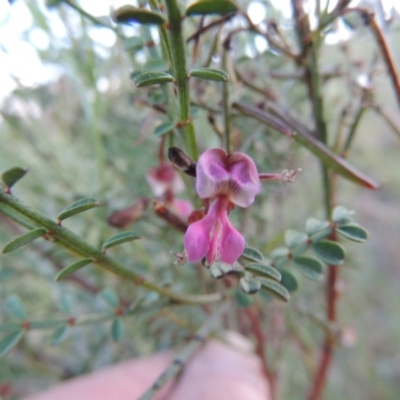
[196,148,230,199]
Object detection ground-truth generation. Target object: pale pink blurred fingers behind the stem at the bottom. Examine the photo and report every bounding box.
[24,341,269,400]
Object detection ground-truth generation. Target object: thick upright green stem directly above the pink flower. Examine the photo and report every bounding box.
[165,0,199,161]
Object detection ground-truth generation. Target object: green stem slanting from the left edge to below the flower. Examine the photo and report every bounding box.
[0,189,222,304]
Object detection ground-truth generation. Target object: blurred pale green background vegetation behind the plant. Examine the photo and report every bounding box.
[0,0,400,400]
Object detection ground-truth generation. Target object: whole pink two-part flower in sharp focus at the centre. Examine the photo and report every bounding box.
[184,148,261,265]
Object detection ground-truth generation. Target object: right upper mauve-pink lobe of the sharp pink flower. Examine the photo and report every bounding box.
[228,153,261,207]
